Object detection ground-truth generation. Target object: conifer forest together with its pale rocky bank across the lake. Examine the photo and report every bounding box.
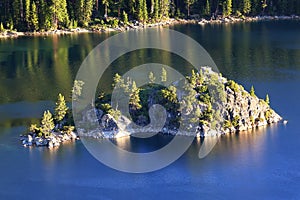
[0,0,300,38]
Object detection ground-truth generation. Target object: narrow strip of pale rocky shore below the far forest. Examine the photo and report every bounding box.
[0,15,300,39]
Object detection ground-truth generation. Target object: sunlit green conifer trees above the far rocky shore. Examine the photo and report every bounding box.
[0,0,300,31]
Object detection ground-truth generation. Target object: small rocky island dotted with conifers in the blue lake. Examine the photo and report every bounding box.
[21,67,285,148]
